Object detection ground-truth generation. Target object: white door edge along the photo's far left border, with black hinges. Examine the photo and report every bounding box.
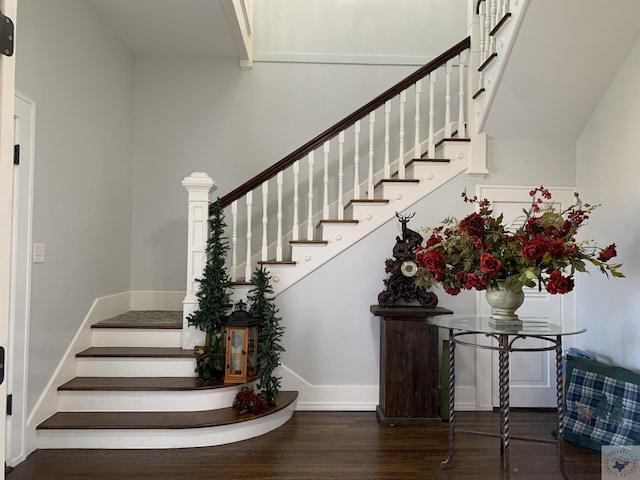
[0,0,17,472]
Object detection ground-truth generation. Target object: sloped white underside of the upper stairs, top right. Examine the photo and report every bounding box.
[485,0,640,139]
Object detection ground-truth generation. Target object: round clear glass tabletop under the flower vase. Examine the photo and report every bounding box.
[427,314,587,337]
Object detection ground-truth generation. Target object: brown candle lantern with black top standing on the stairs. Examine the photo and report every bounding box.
[222,300,260,383]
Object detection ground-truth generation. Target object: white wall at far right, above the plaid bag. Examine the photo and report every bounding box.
[576,35,640,370]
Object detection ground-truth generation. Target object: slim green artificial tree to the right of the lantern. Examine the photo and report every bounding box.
[248,267,284,403]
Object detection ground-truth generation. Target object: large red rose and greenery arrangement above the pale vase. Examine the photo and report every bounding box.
[416,186,624,295]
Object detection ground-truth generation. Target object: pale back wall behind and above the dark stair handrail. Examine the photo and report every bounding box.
[131,0,467,290]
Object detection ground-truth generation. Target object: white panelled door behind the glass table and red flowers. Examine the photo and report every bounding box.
[477,185,575,408]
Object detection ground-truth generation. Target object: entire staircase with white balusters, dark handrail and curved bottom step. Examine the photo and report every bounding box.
[31,0,528,449]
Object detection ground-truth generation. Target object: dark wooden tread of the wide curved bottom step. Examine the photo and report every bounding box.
[37,391,298,430]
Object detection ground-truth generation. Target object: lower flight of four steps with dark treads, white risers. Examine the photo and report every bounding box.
[36,311,297,449]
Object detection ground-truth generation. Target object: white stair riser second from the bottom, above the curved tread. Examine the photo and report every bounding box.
[58,386,239,412]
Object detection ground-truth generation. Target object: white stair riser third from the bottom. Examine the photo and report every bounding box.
[76,357,196,377]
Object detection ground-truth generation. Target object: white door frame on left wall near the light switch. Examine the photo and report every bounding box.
[6,95,35,466]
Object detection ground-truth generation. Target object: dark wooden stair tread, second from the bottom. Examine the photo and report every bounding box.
[58,377,208,392]
